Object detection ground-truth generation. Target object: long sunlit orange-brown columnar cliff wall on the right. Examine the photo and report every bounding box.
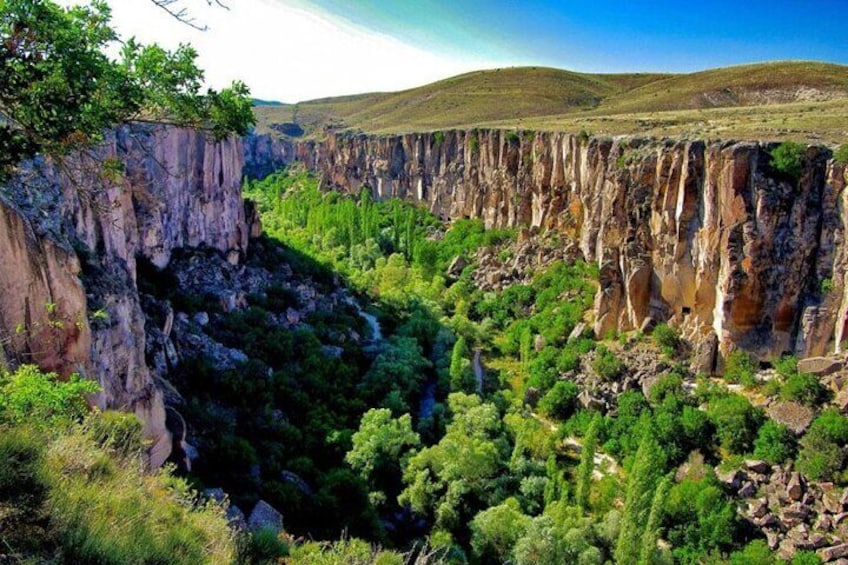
[296,131,848,370]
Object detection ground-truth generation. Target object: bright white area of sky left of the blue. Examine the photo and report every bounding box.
[62,0,494,102]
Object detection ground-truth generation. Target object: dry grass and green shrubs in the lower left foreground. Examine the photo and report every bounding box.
[0,366,235,564]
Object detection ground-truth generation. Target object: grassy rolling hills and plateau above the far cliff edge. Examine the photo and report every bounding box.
[255,62,848,144]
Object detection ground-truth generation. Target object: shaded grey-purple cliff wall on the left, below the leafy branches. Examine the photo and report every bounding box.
[0,127,250,466]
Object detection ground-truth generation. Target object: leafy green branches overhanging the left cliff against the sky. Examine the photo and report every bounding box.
[0,0,253,178]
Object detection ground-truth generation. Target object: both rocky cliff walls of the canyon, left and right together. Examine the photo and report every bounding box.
[0,126,848,466]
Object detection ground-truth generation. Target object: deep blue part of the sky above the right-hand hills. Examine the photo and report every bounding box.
[310,0,848,72]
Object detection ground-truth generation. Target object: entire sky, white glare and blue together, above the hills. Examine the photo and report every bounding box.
[88,0,848,102]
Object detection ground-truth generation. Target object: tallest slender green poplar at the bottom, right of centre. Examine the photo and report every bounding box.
[615,433,665,565]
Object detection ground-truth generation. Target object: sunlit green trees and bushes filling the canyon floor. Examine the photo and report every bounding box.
[236,171,841,563]
